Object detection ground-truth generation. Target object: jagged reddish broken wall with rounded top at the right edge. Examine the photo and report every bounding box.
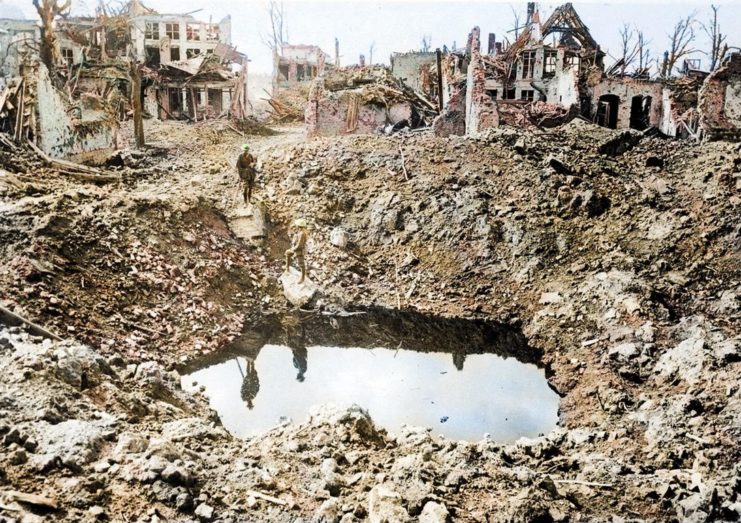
[698,53,741,140]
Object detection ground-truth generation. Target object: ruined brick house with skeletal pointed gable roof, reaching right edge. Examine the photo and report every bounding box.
[434,3,741,138]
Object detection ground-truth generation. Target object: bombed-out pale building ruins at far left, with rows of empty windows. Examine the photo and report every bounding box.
[0,1,248,157]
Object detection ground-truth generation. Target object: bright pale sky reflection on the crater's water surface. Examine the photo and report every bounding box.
[183,346,558,441]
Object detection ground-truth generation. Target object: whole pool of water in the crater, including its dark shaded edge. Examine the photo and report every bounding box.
[182,310,559,442]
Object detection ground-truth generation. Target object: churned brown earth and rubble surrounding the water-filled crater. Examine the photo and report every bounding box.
[0,120,741,523]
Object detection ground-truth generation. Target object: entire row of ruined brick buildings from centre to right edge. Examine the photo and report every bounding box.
[298,3,739,139]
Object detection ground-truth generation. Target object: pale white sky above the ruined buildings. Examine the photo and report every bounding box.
[0,0,741,73]
